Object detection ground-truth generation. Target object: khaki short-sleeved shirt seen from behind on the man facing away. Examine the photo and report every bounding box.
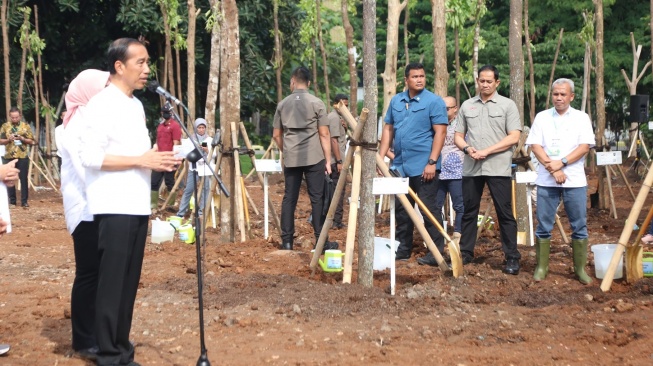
[273,89,329,168]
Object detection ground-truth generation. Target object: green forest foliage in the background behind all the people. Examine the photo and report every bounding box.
[0,0,652,148]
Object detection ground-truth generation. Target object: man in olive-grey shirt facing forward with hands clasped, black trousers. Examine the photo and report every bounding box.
[454,65,521,275]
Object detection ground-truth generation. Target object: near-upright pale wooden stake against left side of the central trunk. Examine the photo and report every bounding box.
[338,146,361,283]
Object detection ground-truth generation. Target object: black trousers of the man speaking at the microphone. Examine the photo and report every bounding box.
[95,214,149,365]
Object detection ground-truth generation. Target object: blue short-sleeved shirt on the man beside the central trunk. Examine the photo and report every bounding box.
[385,89,449,177]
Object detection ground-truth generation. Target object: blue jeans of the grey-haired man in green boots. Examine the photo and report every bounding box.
[535,186,587,239]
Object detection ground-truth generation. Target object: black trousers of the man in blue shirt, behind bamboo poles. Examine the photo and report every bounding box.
[395,175,444,257]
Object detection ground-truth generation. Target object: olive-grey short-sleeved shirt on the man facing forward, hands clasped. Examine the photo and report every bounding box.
[456,93,522,177]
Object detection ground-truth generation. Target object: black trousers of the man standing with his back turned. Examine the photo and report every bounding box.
[281,160,325,243]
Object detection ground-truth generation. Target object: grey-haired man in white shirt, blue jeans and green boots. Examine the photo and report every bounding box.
[526,79,595,285]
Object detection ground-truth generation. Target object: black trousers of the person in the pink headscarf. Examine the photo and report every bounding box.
[70,221,99,351]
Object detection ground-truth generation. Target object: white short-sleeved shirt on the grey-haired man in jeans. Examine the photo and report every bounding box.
[526,107,595,188]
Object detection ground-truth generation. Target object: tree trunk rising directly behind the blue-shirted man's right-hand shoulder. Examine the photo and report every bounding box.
[431,0,449,98]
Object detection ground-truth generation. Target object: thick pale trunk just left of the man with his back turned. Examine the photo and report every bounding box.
[220,0,240,242]
